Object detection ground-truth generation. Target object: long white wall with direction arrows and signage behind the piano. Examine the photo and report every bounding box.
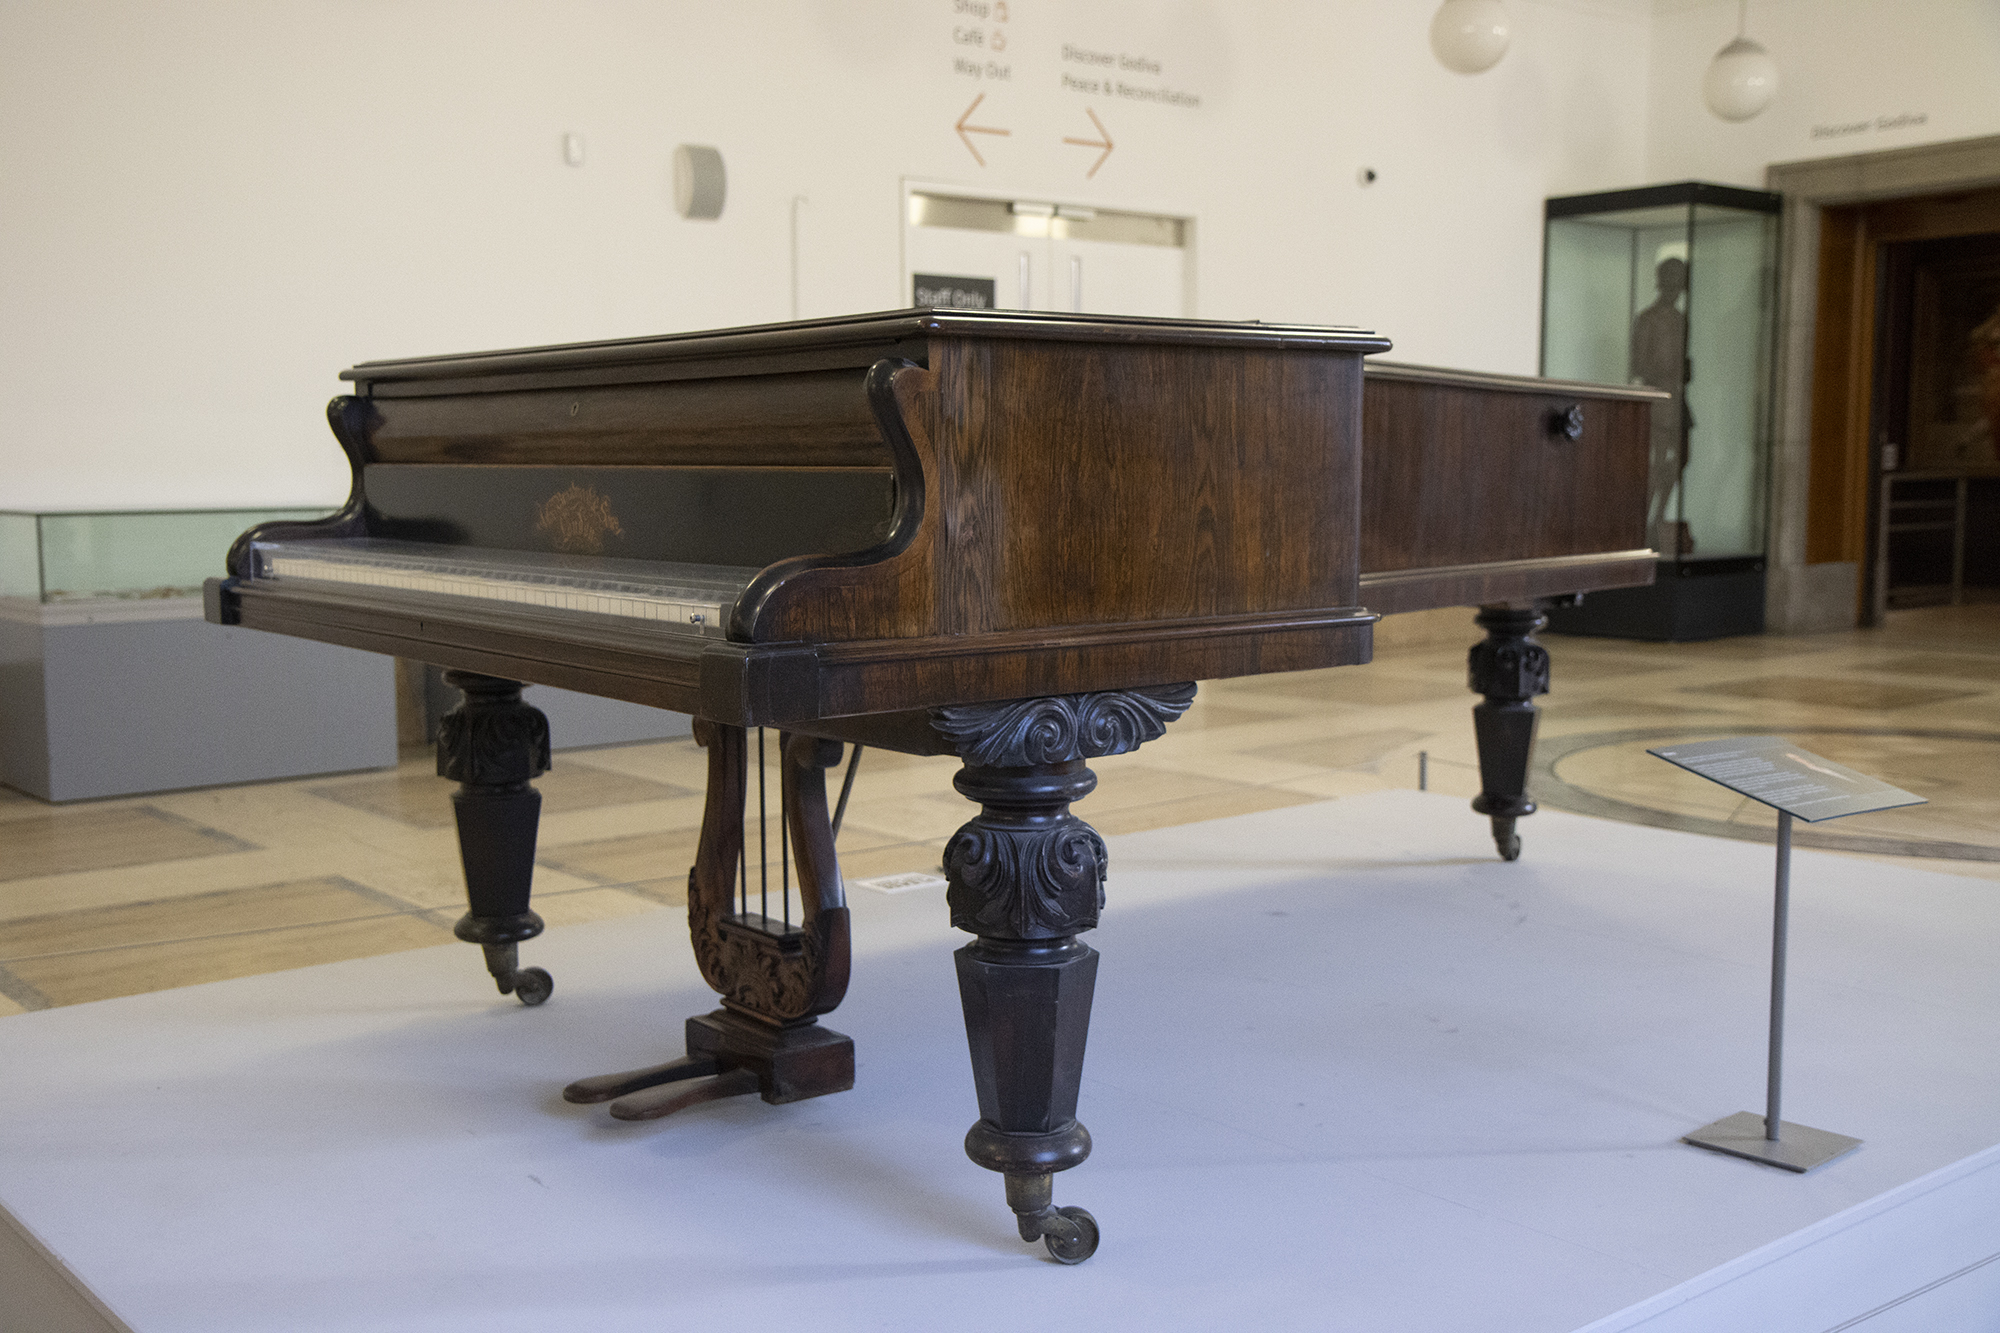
[0,0,1656,508]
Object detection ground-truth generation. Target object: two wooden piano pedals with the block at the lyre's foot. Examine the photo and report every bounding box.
[562,1009,854,1121]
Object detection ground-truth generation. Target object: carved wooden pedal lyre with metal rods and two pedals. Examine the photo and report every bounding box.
[562,721,854,1121]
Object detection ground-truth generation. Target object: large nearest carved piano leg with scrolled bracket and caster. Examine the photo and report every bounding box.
[932,685,1194,1263]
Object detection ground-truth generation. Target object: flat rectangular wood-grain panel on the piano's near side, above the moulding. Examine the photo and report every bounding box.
[932,338,1360,634]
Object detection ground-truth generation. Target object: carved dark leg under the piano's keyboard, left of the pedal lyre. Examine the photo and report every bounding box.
[438,671,556,1005]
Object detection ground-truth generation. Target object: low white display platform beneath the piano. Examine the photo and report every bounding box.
[0,793,2000,1333]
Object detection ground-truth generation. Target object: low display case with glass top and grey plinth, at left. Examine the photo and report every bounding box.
[0,506,396,801]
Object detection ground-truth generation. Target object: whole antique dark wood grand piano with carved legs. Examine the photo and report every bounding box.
[206,310,1662,1263]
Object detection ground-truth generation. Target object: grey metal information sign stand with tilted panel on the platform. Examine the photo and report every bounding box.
[1646,737,1924,1171]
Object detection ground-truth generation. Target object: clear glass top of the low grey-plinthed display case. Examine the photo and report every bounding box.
[0,506,332,602]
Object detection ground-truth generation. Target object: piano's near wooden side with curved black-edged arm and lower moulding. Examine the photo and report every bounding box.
[732,338,1368,717]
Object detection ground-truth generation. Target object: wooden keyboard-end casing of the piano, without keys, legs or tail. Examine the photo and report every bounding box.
[207,314,1386,725]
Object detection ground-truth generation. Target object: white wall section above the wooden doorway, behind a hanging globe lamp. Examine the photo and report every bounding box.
[1646,0,2000,188]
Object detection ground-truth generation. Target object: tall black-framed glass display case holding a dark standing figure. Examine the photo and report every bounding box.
[1542,182,1782,640]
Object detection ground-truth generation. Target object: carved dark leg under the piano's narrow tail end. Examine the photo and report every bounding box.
[1466,606,1548,861]
